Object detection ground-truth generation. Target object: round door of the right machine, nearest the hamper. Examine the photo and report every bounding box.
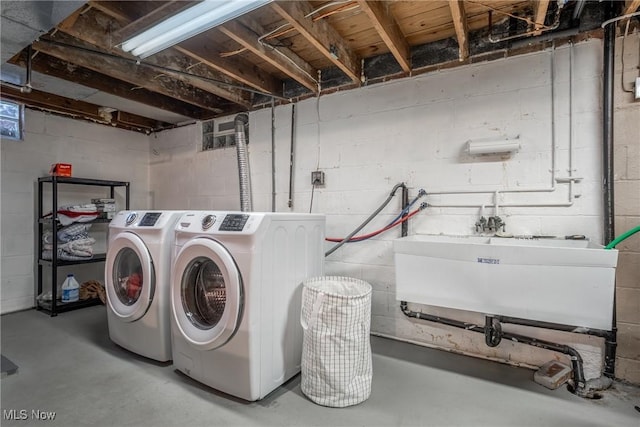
[171,237,244,350]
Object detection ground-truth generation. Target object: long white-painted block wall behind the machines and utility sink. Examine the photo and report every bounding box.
[151,40,620,378]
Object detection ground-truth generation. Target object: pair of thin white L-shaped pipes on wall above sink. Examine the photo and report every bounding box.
[429,45,581,208]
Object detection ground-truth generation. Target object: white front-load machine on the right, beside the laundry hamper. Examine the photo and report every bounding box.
[171,211,325,401]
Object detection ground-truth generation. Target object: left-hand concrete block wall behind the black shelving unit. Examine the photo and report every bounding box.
[0,110,149,313]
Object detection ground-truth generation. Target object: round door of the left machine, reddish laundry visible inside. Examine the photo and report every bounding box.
[105,232,156,322]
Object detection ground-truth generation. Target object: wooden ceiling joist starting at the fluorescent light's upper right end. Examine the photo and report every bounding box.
[270,1,361,84]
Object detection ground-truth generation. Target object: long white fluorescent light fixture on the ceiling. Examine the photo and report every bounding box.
[122,0,271,58]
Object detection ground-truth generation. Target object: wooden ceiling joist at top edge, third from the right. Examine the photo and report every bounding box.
[358,0,411,73]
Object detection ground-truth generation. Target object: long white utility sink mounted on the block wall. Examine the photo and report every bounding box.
[394,235,618,330]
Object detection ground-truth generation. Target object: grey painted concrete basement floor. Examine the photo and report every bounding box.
[0,306,640,427]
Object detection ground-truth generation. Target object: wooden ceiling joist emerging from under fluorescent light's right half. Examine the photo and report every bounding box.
[219,18,318,93]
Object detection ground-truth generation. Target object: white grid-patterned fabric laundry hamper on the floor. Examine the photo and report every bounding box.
[300,276,373,407]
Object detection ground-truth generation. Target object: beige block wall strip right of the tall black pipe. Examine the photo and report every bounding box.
[614,32,640,384]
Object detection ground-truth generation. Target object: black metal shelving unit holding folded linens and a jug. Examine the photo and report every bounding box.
[35,176,129,317]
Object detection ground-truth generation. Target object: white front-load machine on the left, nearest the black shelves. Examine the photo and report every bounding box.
[105,211,184,362]
